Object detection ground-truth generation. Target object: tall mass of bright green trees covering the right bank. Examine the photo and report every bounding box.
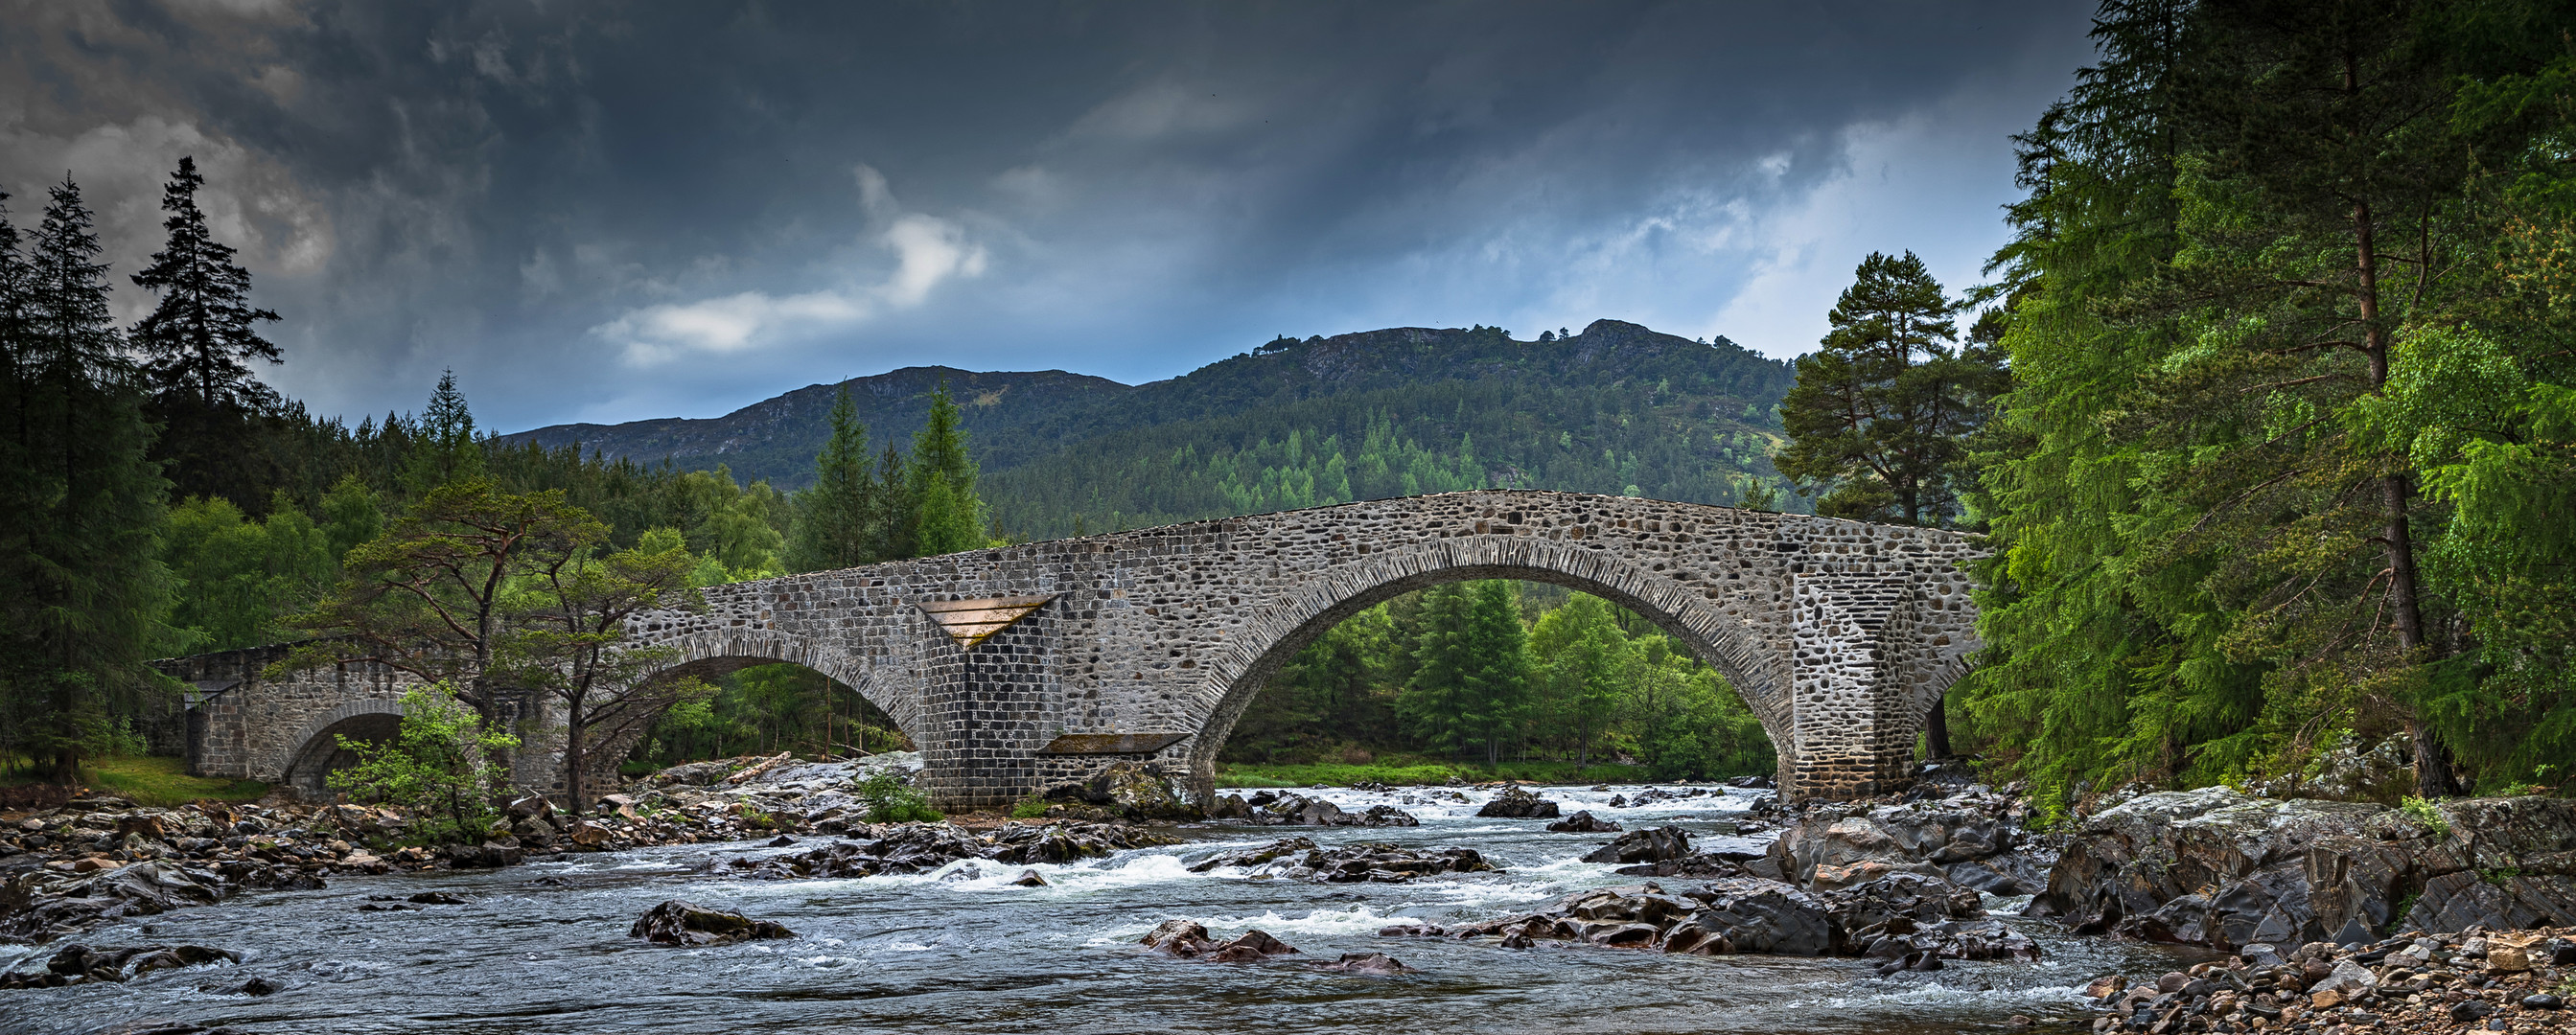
[1955,0,2576,798]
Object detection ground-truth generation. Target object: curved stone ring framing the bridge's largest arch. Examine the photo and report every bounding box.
[1185,536,1796,798]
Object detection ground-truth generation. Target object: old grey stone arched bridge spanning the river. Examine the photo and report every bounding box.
[170,492,1984,809]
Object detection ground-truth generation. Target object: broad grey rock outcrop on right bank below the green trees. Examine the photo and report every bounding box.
[2030,788,2576,950]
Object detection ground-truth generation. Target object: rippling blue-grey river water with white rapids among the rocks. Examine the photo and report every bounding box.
[0,785,2197,1035]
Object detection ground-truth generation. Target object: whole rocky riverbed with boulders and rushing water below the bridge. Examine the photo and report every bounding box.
[0,760,2576,1035]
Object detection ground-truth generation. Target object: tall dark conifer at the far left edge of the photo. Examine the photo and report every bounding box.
[0,177,170,783]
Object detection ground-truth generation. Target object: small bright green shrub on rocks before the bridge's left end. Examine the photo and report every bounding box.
[327,685,518,842]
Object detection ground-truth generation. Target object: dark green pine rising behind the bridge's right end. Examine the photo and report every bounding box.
[1773,252,2004,525]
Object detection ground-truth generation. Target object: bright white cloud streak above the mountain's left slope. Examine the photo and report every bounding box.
[590,165,986,365]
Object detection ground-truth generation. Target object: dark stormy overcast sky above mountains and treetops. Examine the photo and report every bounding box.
[0,0,2092,430]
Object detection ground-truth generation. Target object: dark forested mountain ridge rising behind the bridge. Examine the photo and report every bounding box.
[507,319,1796,538]
